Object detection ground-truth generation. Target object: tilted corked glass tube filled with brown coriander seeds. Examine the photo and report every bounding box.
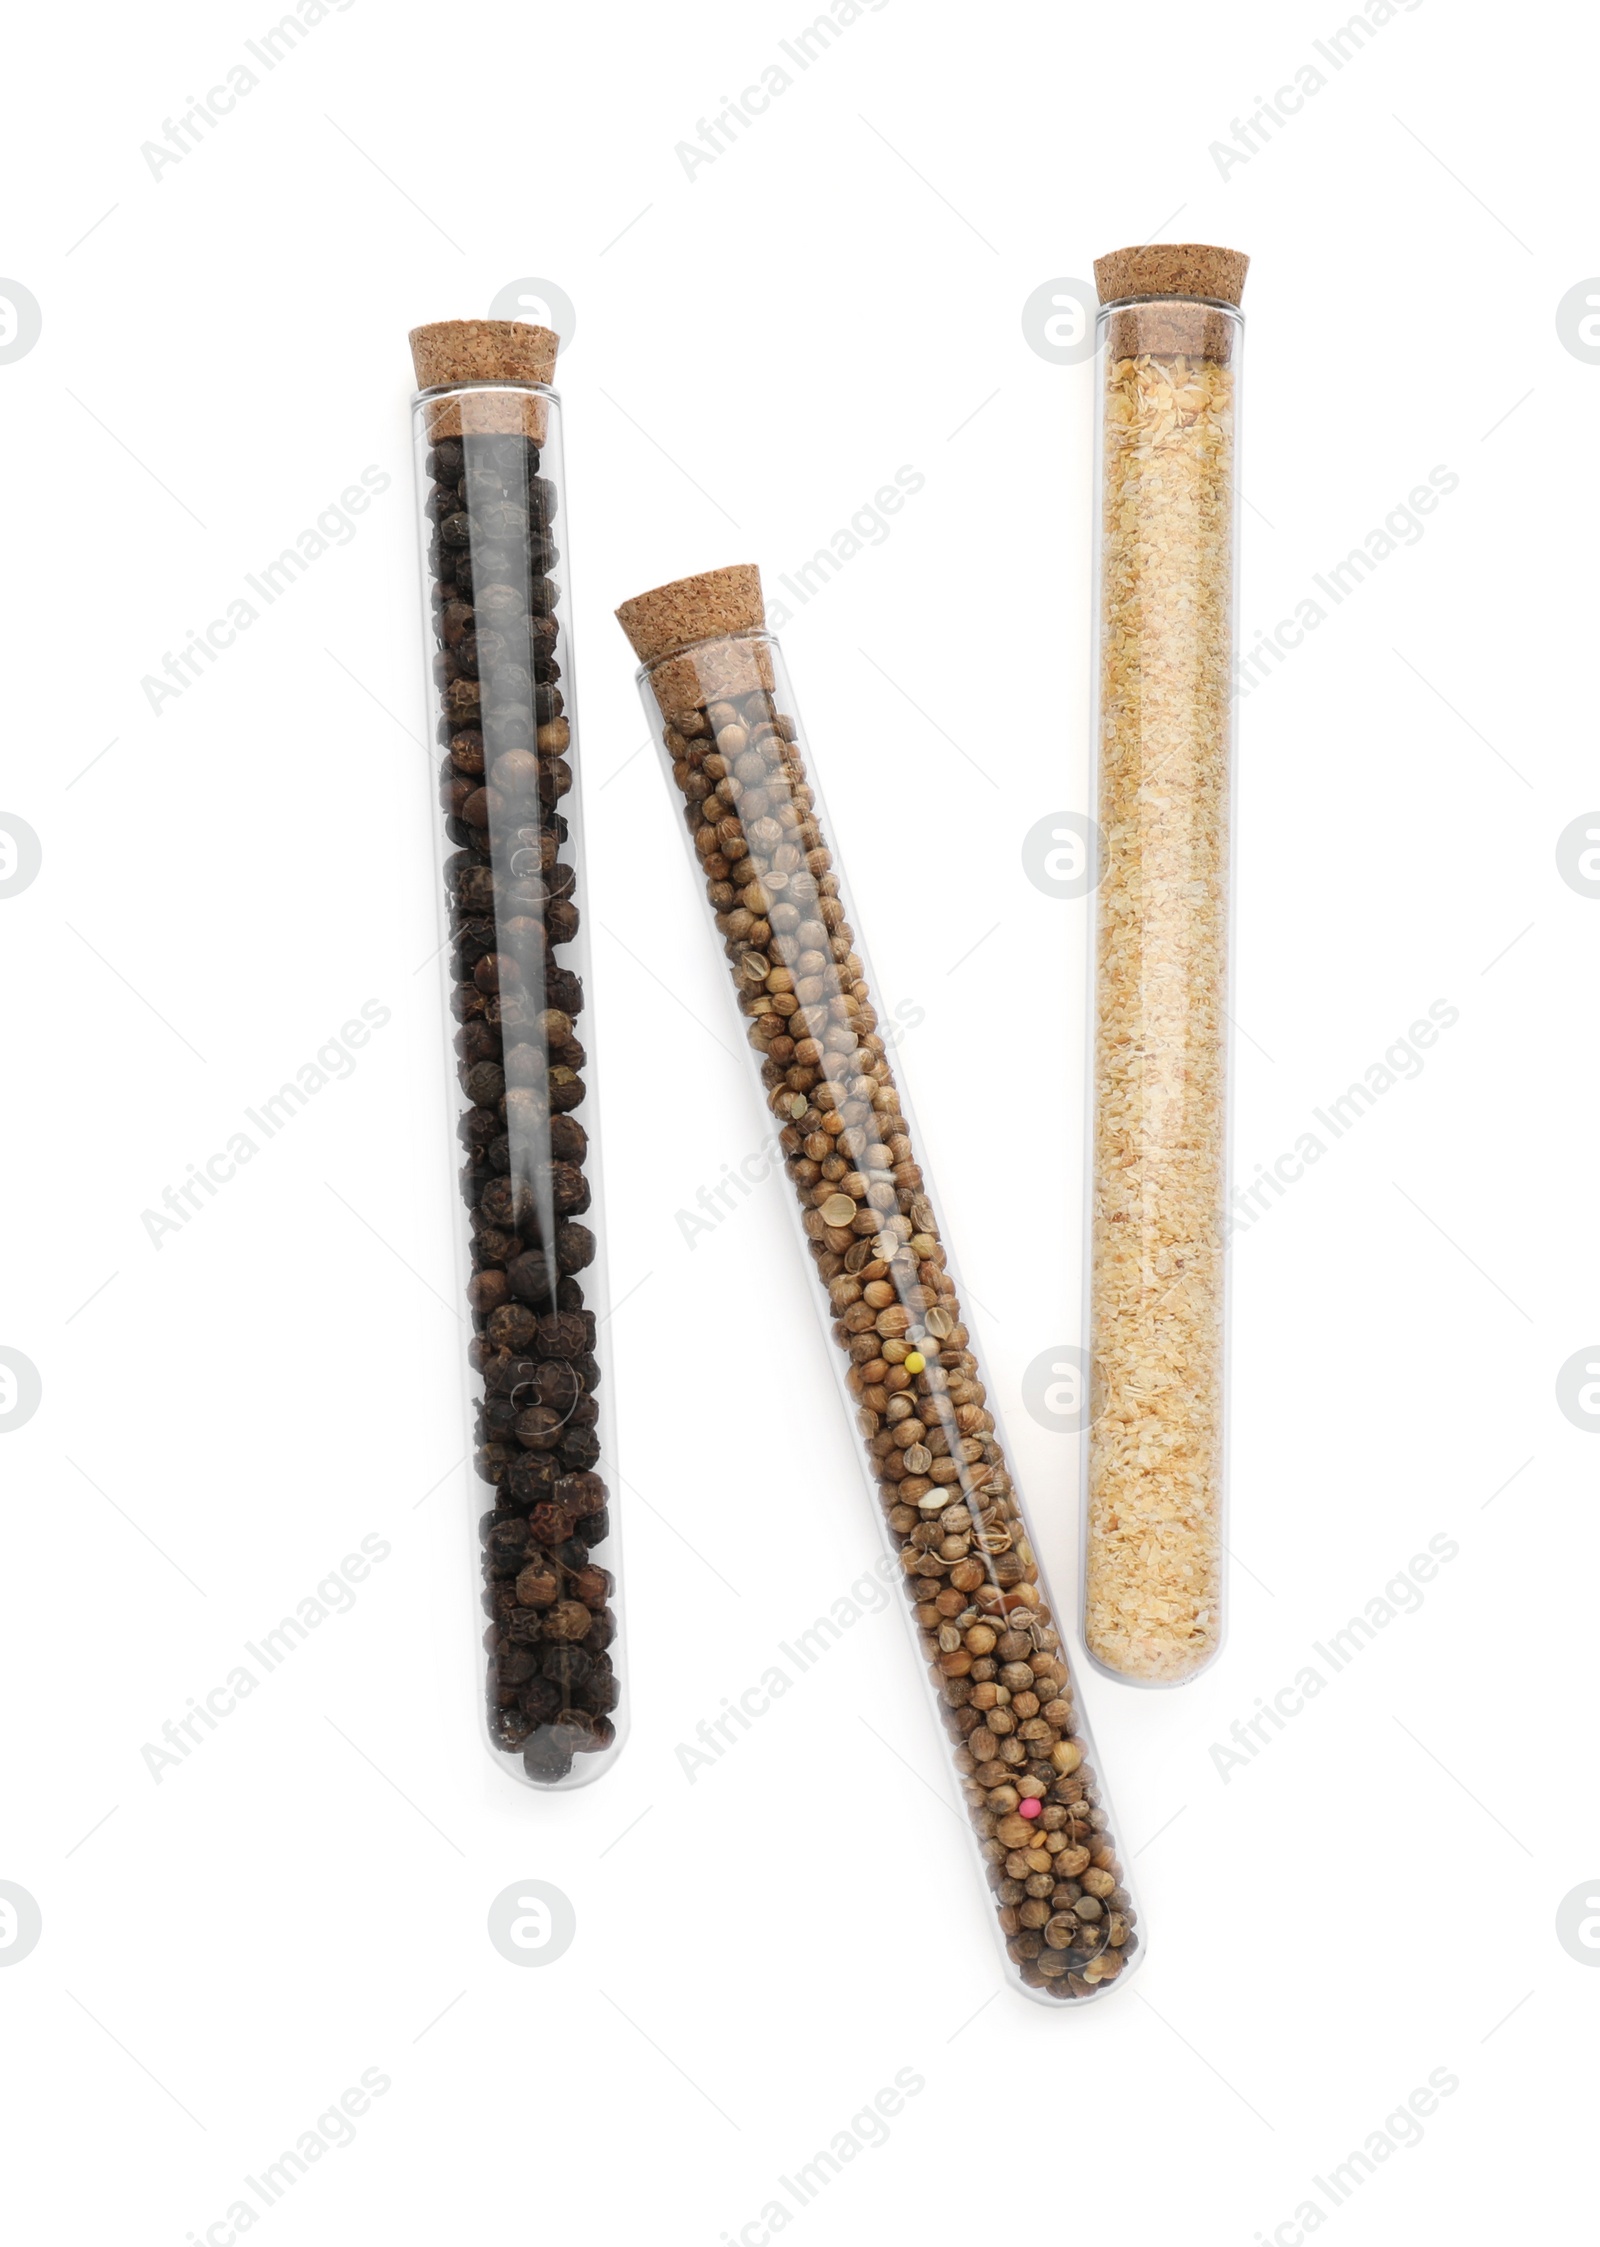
[618,566,1139,2002]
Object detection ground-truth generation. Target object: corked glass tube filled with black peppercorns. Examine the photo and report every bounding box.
[411,319,620,1786]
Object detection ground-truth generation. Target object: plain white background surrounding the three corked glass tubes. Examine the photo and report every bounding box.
[0,0,1600,2247]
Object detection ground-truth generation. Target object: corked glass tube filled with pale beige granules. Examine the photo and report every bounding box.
[1083,243,1247,1685]
